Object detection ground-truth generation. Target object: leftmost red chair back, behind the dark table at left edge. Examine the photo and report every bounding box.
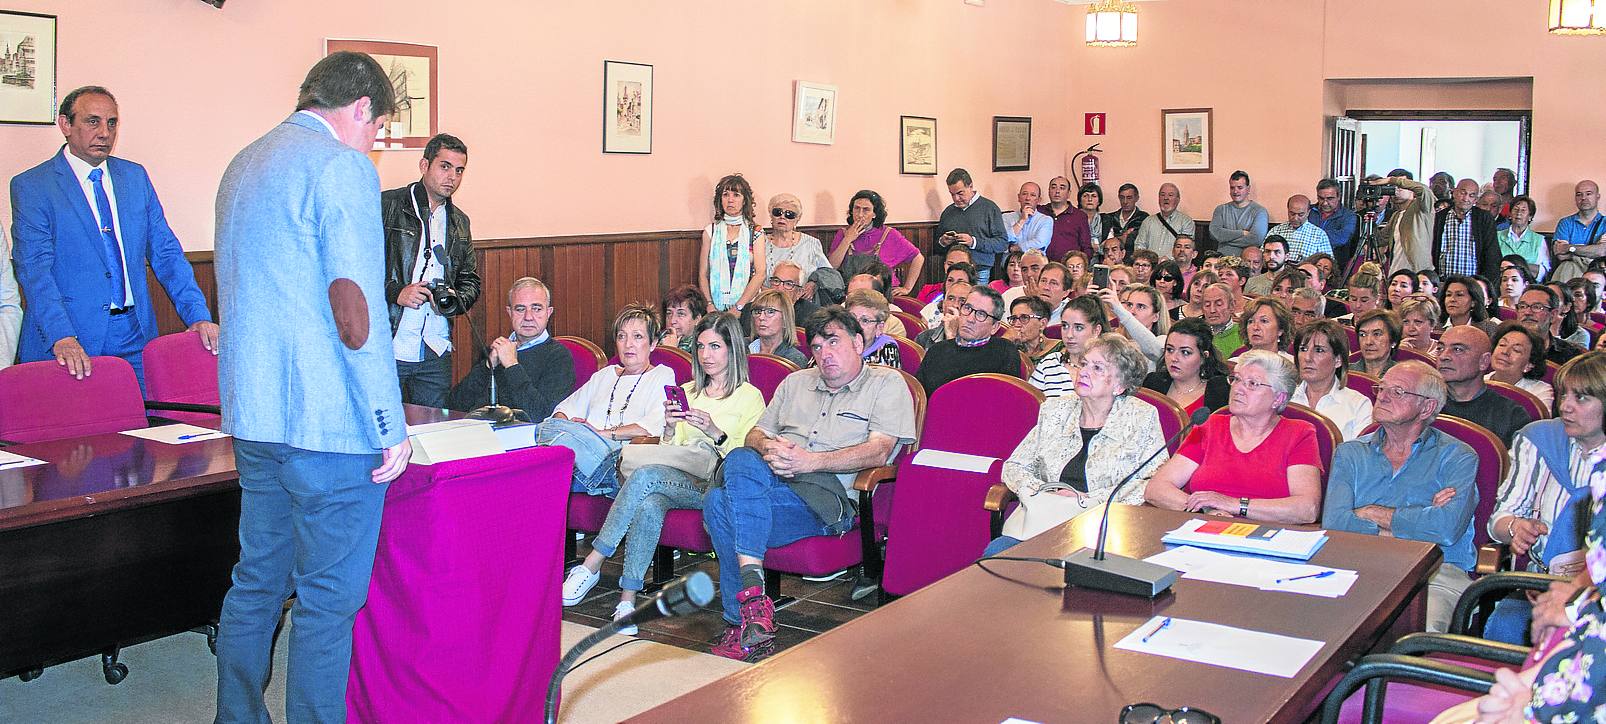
[0,356,149,443]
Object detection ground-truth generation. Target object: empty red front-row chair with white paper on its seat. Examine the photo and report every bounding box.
[882,374,1044,596]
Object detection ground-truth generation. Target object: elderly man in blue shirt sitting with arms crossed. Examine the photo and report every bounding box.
[1322,361,1478,631]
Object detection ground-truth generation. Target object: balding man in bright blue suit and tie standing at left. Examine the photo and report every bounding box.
[11,85,217,385]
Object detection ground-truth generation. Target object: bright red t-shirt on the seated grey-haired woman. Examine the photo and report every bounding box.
[1177,414,1322,498]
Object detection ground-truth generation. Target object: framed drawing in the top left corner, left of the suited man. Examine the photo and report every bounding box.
[0,10,56,125]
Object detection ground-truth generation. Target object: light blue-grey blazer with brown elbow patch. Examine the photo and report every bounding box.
[217,114,406,454]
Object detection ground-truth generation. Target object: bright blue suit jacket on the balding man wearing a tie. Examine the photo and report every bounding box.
[11,146,212,361]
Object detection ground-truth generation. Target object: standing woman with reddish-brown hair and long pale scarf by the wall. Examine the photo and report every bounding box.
[697,173,771,311]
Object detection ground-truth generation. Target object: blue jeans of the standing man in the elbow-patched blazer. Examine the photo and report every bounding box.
[217,440,387,724]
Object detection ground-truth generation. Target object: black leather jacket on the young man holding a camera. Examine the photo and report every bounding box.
[379,183,480,334]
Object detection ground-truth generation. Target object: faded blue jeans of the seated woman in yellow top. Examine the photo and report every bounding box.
[591,466,705,591]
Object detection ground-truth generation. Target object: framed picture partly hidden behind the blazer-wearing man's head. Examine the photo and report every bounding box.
[323,39,440,151]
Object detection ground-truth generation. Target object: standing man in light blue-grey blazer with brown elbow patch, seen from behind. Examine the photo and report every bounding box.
[217,53,413,722]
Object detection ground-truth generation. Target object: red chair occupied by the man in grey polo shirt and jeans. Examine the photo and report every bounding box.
[764,371,925,600]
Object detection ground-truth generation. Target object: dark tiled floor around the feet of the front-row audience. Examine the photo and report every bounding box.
[564,543,875,653]
